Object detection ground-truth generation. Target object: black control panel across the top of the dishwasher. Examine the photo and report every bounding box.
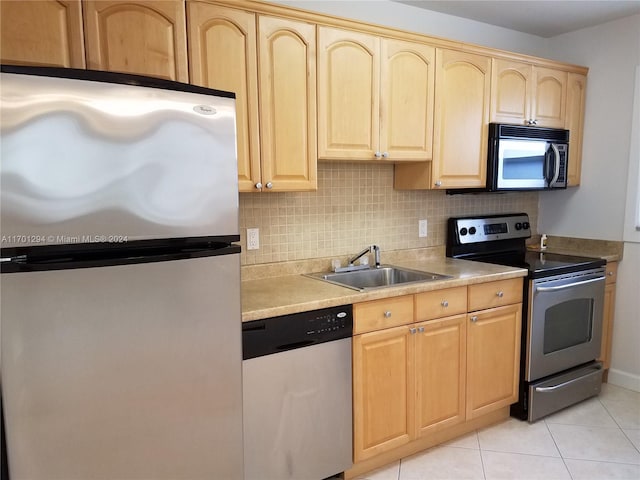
[242,305,353,360]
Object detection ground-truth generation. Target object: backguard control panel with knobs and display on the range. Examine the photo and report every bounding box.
[449,213,531,245]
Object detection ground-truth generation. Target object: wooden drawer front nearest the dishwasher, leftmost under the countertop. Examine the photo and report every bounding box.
[353,295,413,335]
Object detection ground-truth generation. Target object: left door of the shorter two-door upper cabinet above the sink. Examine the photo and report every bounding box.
[318,27,380,160]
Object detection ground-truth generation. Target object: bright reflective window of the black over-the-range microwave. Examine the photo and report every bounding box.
[501,140,547,180]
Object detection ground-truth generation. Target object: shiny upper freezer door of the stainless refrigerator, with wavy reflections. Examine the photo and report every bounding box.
[0,67,239,248]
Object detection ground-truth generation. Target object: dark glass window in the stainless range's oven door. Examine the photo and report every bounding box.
[544,298,593,355]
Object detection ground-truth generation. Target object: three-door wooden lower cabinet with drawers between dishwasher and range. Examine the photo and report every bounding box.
[353,278,522,468]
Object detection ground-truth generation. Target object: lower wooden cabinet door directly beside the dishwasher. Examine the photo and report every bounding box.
[353,326,415,462]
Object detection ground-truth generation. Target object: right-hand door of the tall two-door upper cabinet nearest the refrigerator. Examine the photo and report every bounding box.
[258,16,317,191]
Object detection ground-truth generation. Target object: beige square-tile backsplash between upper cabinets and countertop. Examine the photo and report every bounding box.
[240,163,538,265]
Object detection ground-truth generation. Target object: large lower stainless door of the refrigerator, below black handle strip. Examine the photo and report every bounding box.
[1,254,243,480]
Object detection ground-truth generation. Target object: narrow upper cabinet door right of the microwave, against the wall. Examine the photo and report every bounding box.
[564,73,587,187]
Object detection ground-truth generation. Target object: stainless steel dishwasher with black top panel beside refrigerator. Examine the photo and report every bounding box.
[242,305,353,480]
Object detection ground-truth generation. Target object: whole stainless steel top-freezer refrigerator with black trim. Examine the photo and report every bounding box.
[0,66,243,480]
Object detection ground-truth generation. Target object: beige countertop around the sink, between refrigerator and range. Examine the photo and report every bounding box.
[241,257,527,322]
